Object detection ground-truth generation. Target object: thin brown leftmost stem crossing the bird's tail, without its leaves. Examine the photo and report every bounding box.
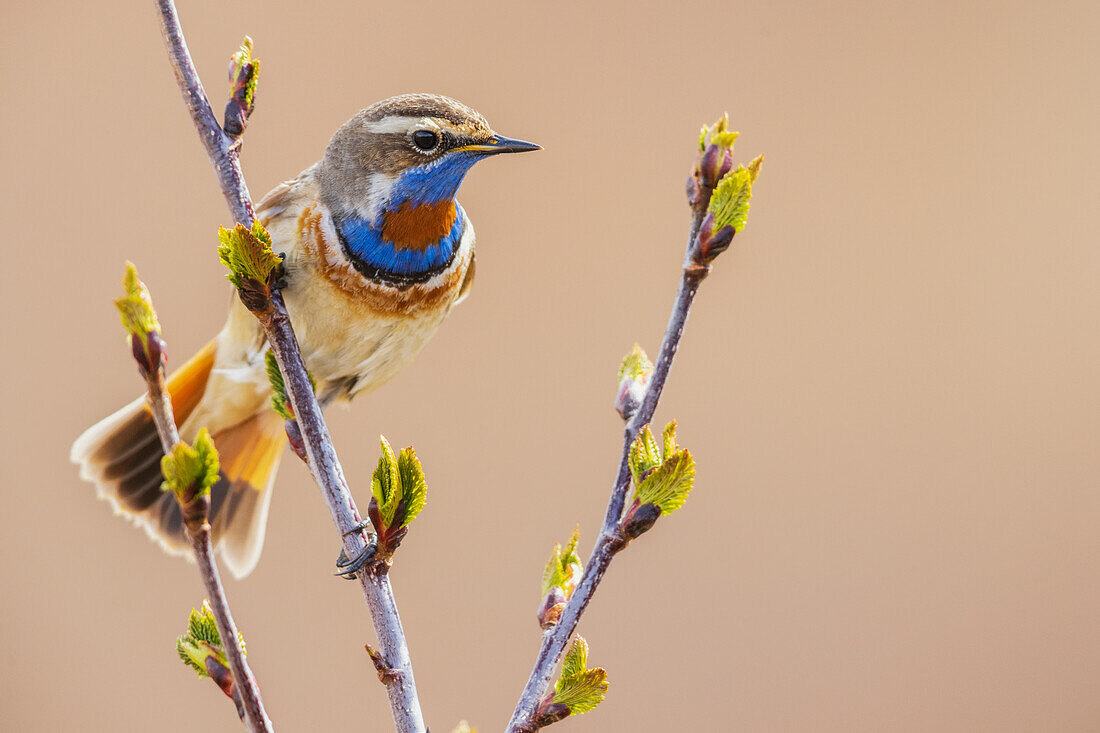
[130,331,275,733]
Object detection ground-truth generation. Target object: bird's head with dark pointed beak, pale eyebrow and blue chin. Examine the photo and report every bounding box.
[320,94,539,226]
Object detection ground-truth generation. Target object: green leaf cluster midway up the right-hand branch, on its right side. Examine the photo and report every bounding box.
[628,420,695,515]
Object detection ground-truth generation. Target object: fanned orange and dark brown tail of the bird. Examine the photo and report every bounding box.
[70,341,286,578]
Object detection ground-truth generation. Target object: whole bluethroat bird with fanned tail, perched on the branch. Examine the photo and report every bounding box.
[72,95,539,577]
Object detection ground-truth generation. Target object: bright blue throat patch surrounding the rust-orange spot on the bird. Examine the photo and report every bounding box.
[334,153,483,286]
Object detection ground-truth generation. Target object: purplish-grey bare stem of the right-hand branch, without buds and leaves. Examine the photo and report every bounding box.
[507,210,710,733]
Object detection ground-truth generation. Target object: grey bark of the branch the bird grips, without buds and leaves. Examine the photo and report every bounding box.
[157,0,427,733]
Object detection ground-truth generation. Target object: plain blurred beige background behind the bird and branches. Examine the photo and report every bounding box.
[0,0,1100,733]
